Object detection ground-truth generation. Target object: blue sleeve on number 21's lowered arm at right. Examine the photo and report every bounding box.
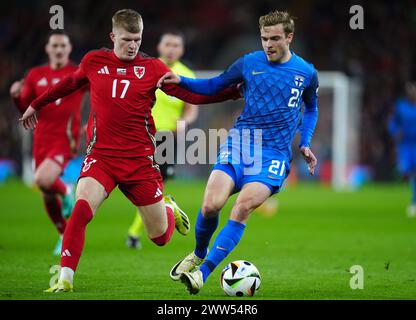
[299,71,319,147]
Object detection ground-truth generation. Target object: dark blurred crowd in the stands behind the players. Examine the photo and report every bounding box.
[0,0,416,180]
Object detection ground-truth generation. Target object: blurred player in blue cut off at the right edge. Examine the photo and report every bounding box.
[389,82,416,217]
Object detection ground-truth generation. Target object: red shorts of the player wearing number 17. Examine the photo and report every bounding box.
[78,152,163,206]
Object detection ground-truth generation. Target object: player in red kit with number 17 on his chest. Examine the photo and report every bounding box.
[20,9,240,292]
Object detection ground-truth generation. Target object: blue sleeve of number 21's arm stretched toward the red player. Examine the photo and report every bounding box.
[179,57,244,95]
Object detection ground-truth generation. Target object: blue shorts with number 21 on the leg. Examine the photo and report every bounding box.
[212,142,291,194]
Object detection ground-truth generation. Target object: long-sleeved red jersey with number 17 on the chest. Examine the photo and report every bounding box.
[32,49,240,158]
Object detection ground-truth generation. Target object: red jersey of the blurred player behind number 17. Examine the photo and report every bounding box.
[14,62,84,154]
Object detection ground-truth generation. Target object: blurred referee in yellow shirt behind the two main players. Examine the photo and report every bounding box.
[127,31,198,249]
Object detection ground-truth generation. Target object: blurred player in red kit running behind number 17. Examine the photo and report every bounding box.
[10,31,84,255]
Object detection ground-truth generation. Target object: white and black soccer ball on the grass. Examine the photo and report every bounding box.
[221,260,261,297]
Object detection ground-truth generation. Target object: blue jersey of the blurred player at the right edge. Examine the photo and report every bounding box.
[389,99,416,145]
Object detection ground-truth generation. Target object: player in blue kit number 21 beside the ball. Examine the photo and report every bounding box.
[158,11,318,294]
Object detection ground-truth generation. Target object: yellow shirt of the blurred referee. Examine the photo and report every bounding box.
[152,61,195,131]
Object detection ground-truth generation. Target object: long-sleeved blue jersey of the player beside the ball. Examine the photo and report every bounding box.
[180,51,318,159]
